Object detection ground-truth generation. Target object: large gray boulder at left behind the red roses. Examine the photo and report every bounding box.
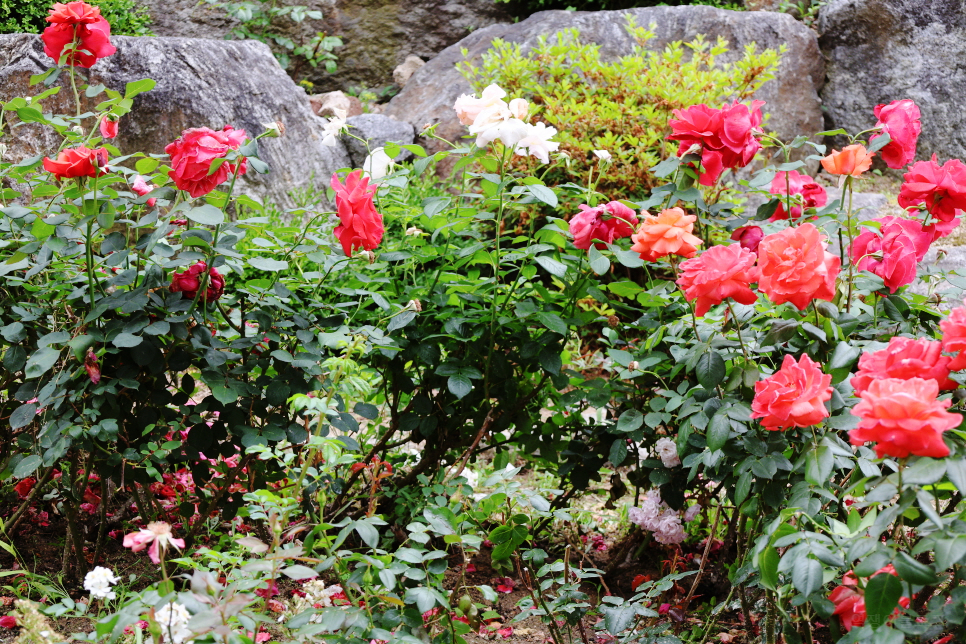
[0,34,350,206]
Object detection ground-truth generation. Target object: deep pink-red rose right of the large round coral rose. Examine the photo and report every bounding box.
[849,217,932,293]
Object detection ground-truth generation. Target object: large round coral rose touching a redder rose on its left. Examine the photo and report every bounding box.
[758,224,841,311]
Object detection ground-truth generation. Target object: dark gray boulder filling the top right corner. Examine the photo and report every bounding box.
[819,0,966,162]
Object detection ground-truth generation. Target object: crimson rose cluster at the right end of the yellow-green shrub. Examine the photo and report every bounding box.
[667,101,765,186]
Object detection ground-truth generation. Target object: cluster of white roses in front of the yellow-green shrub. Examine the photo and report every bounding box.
[453,85,560,163]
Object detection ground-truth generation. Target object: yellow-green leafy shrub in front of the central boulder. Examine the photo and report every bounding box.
[458,16,782,199]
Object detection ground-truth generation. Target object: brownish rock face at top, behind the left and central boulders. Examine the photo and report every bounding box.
[141,0,510,92]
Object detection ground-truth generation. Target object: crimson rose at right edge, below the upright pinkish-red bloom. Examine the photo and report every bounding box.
[899,154,966,221]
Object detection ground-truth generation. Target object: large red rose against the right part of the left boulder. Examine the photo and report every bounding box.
[164,125,248,199]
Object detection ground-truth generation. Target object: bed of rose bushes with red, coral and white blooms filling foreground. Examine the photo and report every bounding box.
[0,2,966,644]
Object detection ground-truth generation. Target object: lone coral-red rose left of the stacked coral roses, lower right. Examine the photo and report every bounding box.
[751,353,832,431]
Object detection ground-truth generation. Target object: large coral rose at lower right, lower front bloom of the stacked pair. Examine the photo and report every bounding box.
[849,378,962,458]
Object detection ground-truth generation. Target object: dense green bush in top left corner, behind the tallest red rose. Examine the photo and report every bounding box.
[0,0,153,36]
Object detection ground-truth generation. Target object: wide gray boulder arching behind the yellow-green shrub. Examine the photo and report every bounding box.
[383,6,825,152]
